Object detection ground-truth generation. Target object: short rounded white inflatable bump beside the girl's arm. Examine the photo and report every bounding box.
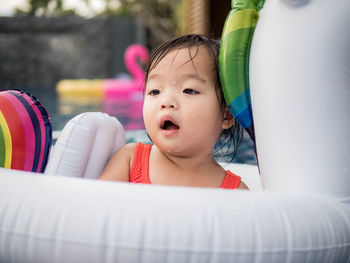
[45,112,125,179]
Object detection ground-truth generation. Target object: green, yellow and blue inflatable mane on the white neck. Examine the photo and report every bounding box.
[219,0,265,141]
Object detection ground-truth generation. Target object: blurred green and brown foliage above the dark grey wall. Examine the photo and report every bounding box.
[14,0,184,46]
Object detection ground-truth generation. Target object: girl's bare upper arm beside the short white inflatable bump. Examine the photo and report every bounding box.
[98,143,136,182]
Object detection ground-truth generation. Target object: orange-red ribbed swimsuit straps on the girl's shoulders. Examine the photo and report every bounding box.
[129,142,241,189]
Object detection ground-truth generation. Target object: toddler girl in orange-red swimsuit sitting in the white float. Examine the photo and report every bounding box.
[99,35,248,189]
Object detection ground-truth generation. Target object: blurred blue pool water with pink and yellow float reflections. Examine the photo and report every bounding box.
[20,87,256,164]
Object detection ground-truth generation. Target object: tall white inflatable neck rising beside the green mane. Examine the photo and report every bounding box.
[250,0,350,201]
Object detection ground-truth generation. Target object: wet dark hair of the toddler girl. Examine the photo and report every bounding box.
[146,34,243,161]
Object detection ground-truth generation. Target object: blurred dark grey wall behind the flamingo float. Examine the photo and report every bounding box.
[0,16,147,89]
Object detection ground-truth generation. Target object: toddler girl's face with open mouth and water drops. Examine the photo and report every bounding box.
[143,47,231,156]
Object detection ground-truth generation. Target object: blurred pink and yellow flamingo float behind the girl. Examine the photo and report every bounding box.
[56,44,149,99]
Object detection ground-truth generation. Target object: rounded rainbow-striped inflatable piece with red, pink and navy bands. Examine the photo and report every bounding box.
[0,90,52,172]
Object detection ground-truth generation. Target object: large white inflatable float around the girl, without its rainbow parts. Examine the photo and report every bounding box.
[0,0,350,263]
